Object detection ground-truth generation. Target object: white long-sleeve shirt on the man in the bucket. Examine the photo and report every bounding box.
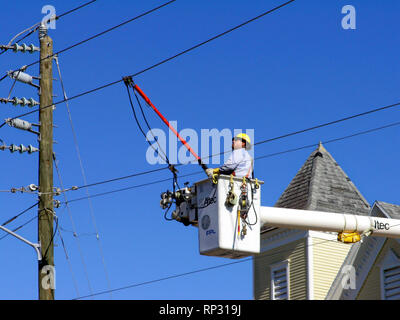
[219,148,253,177]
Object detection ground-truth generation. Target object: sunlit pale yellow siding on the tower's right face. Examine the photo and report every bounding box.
[311,238,351,300]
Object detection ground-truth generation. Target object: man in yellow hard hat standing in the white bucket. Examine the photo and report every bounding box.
[206,133,253,178]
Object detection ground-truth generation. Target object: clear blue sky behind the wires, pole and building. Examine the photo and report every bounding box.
[0,0,400,300]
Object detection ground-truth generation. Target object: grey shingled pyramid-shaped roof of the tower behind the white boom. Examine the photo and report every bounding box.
[275,143,370,215]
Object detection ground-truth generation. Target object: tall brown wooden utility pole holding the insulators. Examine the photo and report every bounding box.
[38,25,55,300]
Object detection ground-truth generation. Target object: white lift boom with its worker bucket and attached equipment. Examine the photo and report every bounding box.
[161,176,400,259]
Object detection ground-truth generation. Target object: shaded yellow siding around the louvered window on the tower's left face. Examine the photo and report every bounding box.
[253,235,307,300]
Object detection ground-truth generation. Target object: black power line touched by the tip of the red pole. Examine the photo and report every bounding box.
[0,0,295,128]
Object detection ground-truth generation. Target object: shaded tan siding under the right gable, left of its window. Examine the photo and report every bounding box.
[357,239,400,300]
